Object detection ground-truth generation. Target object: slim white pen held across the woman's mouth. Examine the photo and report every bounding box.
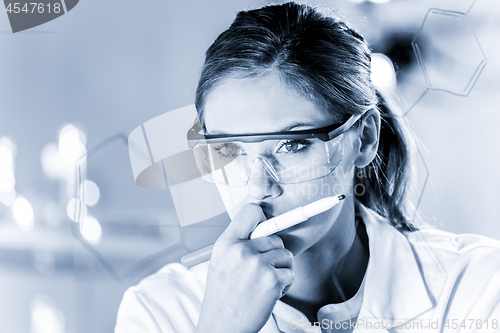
[181,194,345,268]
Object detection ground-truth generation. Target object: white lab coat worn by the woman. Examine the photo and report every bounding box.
[115,204,500,333]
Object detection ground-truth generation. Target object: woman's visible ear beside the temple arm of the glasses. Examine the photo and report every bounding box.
[354,109,380,168]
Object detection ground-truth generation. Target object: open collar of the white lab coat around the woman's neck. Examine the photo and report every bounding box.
[268,203,434,332]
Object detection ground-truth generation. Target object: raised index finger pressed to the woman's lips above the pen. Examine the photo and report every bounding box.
[224,203,266,240]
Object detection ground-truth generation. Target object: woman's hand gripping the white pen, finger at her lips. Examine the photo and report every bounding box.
[196,204,294,333]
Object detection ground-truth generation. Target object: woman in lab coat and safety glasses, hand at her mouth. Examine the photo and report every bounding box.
[116,3,500,332]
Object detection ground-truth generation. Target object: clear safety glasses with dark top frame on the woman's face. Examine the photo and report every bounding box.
[187,111,361,186]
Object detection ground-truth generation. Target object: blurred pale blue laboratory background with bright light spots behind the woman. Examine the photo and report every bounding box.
[0,0,500,333]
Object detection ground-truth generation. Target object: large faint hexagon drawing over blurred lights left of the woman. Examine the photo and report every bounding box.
[71,133,185,282]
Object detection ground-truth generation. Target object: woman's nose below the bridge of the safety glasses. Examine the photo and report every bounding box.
[248,158,283,201]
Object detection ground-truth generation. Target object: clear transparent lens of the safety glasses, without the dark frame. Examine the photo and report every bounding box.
[194,135,343,186]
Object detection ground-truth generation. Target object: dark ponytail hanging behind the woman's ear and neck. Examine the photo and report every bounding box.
[355,92,416,230]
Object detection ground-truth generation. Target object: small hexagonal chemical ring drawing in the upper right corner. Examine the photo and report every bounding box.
[412,8,486,96]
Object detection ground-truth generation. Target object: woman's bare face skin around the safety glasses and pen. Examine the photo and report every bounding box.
[204,74,356,256]
